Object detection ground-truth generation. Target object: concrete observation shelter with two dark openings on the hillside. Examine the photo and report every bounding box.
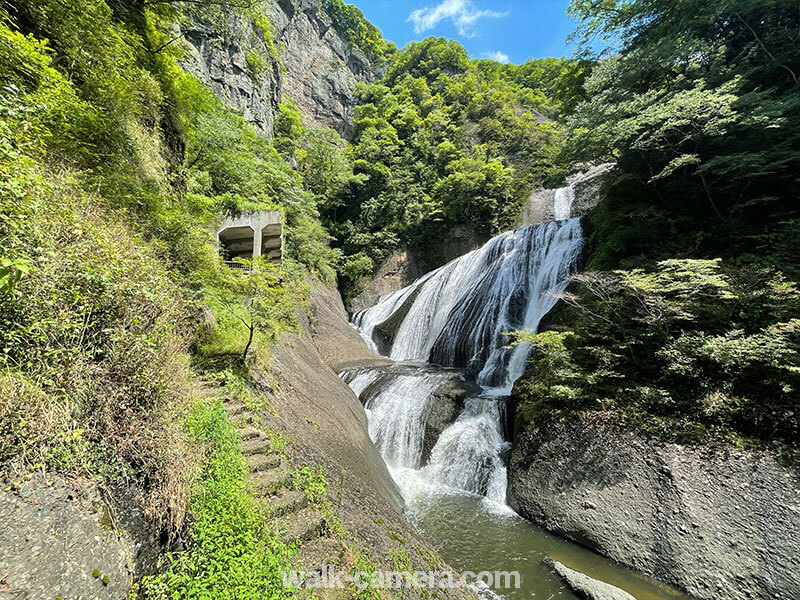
[216,210,283,269]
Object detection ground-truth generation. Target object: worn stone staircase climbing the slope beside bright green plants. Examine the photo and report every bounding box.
[216,396,349,598]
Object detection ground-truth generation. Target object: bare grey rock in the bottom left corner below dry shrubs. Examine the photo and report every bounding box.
[0,473,158,600]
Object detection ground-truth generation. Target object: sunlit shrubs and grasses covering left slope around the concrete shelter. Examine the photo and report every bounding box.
[0,0,337,535]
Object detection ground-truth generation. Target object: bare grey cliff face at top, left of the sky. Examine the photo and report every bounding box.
[181,0,376,137]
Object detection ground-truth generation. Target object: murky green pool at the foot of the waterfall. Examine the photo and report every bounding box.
[408,495,689,600]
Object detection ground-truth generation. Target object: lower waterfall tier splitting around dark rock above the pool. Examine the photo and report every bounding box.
[342,364,510,506]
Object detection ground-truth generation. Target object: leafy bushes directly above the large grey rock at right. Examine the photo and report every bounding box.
[516,260,800,446]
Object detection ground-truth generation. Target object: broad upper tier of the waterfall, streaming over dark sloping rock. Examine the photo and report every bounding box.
[353,219,583,388]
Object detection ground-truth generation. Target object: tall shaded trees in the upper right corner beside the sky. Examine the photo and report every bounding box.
[566,0,800,270]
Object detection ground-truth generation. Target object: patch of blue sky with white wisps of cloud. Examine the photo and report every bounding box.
[346,0,575,64]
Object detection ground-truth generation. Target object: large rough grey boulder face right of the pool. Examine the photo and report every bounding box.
[509,413,800,600]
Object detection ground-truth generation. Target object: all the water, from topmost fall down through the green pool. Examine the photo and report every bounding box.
[342,188,685,600]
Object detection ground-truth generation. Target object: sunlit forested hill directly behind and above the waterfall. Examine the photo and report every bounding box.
[332,38,580,292]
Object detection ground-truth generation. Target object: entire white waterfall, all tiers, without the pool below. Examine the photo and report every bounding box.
[345,213,583,505]
